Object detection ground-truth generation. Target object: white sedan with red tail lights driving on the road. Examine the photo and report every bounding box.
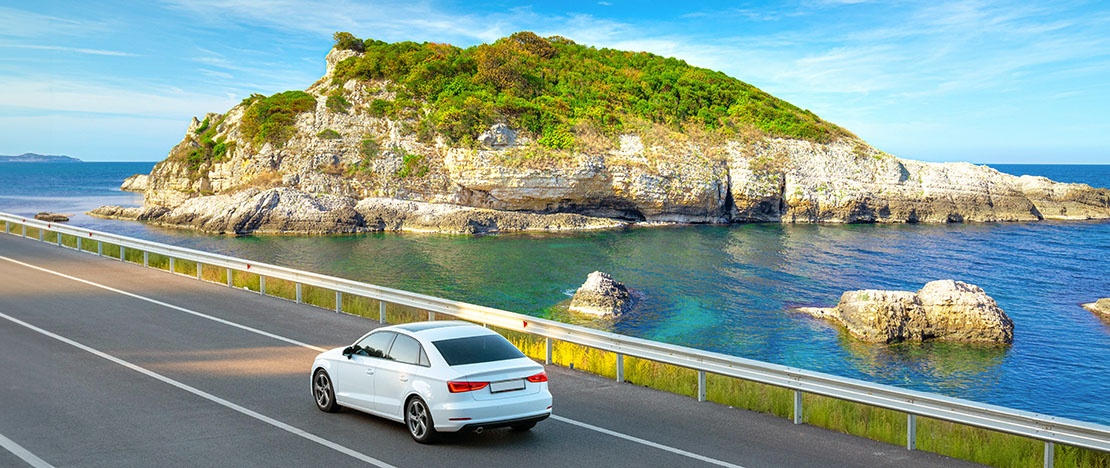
[312,321,552,444]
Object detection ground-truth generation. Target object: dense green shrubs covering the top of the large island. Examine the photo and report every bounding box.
[329,32,849,150]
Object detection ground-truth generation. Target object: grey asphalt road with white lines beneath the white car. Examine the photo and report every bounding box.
[0,235,973,468]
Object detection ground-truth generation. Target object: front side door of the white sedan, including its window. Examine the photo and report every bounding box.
[334,332,397,411]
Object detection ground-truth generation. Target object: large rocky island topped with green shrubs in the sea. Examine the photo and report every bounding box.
[90,32,1110,235]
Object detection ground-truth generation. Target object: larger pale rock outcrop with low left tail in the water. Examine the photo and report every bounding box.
[799,279,1013,344]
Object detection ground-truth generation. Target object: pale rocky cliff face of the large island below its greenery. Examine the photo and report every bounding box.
[93,49,1110,233]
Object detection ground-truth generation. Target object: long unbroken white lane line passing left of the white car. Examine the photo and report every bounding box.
[0,312,395,468]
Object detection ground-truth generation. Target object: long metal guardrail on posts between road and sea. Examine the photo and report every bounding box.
[0,213,1110,467]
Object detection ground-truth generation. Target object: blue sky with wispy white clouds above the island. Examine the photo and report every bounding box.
[0,0,1110,164]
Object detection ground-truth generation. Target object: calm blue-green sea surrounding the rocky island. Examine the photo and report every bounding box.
[0,163,1110,424]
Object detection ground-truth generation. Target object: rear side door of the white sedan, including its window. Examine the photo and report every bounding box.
[374,334,427,418]
